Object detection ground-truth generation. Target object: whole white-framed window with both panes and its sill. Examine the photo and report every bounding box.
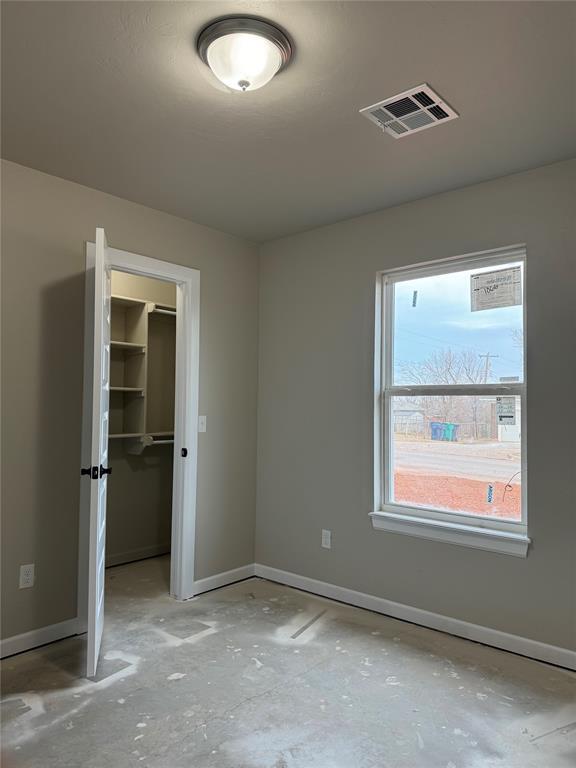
[371,248,529,556]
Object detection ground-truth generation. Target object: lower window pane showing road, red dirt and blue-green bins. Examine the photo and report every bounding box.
[390,395,522,520]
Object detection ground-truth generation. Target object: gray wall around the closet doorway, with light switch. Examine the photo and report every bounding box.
[2,162,258,637]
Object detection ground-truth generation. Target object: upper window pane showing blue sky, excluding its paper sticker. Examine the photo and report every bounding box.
[393,262,524,386]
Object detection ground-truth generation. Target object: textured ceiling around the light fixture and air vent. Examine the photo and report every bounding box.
[2,2,576,240]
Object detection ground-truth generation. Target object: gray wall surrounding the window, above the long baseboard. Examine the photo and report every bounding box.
[256,161,576,648]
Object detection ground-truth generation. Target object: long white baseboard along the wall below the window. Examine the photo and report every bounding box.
[254,563,576,670]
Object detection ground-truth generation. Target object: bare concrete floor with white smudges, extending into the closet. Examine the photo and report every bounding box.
[2,558,576,768]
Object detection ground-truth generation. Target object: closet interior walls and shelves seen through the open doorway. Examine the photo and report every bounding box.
[106,271,176,566]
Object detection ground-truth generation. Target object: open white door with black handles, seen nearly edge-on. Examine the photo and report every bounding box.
[83,228,111,677]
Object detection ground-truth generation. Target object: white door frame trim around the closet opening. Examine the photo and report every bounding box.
[78,243,200,633]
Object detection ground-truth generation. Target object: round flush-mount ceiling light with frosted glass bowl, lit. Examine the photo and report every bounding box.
[197,16,292,91]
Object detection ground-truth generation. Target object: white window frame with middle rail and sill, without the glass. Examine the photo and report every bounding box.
[370,249,530,557]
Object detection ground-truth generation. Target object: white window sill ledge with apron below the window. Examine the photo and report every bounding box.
[370,511,530,557]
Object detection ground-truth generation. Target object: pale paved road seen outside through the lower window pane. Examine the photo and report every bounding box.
[395,441,520,482]
